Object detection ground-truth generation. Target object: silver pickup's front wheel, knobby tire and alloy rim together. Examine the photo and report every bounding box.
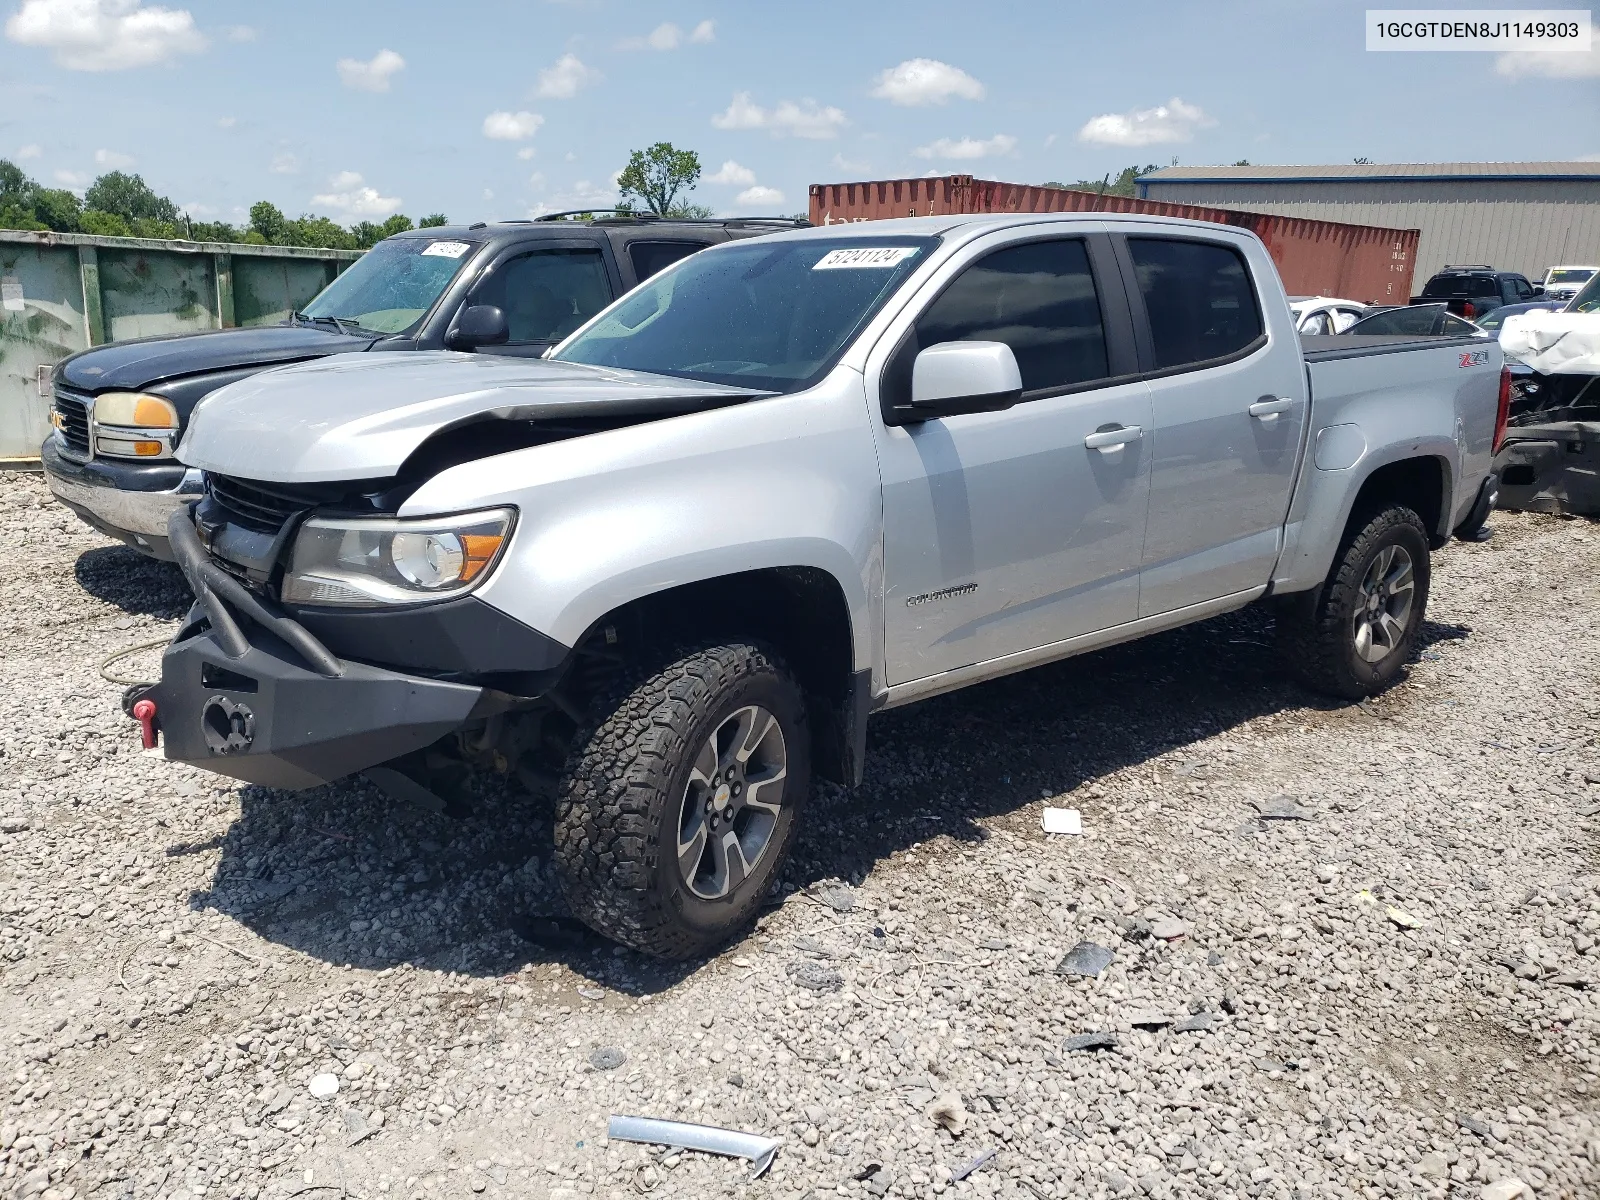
[555,643,811,958]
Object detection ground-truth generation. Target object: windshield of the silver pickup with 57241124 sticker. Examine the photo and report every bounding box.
[550,237,939,392]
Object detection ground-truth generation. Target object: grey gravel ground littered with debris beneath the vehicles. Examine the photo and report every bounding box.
[0,475,1600,1200]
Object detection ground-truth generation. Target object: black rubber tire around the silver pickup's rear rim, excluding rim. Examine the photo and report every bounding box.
[1277,504,1430,701]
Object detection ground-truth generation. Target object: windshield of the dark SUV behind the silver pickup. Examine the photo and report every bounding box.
[304,237,472,333]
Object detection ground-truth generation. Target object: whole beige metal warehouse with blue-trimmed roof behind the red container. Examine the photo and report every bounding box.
[1138,163,1600,288]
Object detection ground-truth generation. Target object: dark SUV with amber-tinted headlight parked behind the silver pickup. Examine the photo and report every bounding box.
[40,213,808,558]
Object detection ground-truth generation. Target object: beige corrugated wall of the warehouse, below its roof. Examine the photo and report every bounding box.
[1147,179,1600,286]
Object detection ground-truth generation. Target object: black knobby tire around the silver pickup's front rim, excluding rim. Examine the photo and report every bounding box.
[555,642,811,958]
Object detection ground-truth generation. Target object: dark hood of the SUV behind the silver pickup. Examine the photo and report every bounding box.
[58,325,376,392]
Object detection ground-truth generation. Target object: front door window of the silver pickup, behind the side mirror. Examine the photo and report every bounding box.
[917,238,1110,392]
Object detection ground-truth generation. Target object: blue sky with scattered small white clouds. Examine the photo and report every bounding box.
[0,0,1600,221]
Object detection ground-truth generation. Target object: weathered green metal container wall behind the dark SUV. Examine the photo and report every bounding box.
[0,230,362,461]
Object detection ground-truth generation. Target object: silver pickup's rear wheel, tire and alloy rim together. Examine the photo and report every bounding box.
[1278,504,1430,699]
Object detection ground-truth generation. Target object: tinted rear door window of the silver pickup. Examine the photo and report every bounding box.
[1128,237,1261,370]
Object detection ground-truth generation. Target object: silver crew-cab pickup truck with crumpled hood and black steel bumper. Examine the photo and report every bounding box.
[128,213,1507,957]
